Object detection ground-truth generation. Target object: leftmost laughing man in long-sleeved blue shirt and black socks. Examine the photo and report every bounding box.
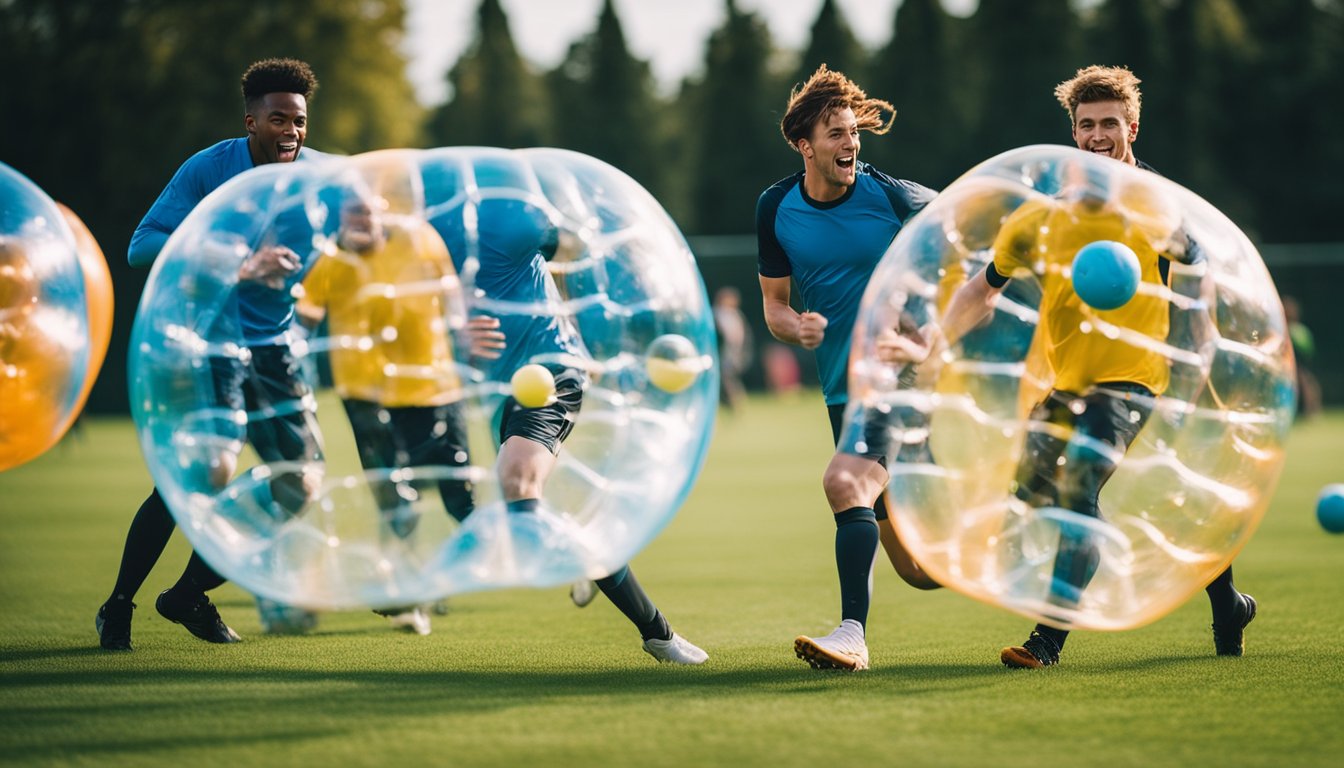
[95,59,321,651]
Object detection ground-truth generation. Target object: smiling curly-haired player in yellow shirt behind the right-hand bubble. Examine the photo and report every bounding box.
[897,66,1255,668]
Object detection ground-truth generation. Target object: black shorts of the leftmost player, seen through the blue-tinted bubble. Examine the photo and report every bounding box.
[210,344,323,461]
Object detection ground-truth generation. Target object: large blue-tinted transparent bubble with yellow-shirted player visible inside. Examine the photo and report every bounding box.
[132,148,718,609]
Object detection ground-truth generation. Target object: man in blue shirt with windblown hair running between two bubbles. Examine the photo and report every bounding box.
[757,65,938,670]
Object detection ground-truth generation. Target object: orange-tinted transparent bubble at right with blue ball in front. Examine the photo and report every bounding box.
[847,147,1294,629]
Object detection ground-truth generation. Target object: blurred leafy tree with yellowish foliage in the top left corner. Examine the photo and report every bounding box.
[0,0,419,412]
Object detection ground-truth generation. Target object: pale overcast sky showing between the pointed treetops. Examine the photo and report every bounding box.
[407,0,972,105]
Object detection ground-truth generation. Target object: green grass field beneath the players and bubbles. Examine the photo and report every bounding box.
[0,394,1344,767]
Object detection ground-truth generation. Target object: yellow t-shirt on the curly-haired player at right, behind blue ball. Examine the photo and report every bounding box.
[993,200,1171,394]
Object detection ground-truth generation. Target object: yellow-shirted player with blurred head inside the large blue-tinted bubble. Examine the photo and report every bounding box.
[297,191,473,635]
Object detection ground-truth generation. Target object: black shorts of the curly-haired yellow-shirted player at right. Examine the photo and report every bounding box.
[1015,382,1153,518]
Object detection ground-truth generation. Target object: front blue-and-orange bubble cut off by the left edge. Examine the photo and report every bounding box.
[0,163,98,471]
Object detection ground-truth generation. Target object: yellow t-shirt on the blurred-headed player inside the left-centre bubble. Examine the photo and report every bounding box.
[301,225,461,406]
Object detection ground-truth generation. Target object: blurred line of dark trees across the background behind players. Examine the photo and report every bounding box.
[0,0,1344,410]
